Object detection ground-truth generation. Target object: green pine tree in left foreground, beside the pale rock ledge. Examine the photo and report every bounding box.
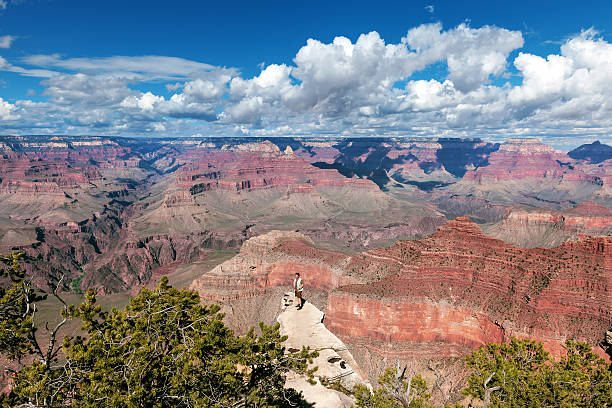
[0,255,316,408]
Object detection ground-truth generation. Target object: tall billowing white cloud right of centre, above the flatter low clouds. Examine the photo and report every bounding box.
[224,23,523,119]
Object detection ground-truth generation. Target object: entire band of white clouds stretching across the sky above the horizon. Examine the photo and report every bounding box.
[0,23,612,146]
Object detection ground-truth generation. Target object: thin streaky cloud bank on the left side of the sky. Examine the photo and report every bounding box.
[0,55,237,127]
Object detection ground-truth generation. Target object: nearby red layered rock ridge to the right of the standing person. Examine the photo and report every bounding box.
[328,218,612,352]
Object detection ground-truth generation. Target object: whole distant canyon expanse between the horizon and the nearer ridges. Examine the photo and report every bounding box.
[0,136,612,293]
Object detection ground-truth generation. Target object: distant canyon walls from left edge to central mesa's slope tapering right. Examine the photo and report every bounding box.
[0,137,443,293]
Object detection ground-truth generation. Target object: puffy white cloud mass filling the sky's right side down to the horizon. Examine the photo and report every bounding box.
[222,24,612,142]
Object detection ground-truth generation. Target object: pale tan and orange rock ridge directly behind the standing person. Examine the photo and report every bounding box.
[190,231,352,331]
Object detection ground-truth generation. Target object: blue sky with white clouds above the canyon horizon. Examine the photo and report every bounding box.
[0,0,612,150]
